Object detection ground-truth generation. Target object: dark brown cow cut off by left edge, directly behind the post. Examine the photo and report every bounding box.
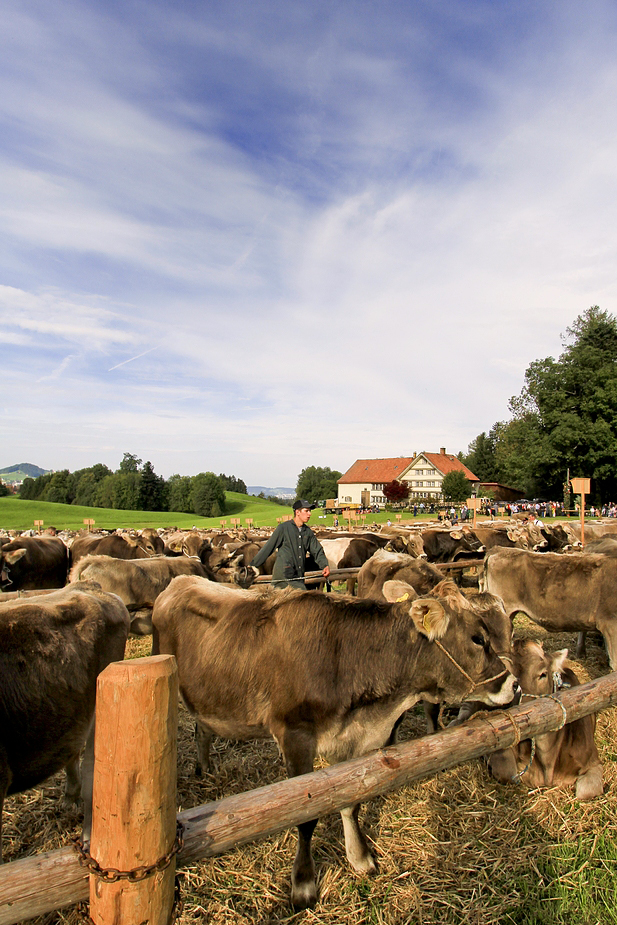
[0,582,129,860]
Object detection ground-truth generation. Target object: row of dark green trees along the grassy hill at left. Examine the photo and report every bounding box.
[19,453,247,517]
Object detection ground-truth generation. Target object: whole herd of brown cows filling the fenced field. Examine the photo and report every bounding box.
[0,522,617,907]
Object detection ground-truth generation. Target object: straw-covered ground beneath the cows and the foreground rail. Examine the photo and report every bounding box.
[4,618,617,925]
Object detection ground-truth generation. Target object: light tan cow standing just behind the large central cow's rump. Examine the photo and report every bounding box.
[69,555,213,636]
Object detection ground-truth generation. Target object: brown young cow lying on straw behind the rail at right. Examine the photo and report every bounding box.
[489,639,603,800]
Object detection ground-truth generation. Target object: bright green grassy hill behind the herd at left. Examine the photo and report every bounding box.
[0,491,296,530]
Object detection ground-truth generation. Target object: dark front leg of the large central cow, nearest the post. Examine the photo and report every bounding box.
[275,729,317,909]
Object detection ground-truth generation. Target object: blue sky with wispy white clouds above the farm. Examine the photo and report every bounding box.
[0,0,617,486]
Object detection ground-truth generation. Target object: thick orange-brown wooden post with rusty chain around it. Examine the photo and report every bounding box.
[90,655,178,925]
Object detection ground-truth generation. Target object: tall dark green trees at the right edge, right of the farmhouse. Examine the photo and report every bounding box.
[459,305,617,506]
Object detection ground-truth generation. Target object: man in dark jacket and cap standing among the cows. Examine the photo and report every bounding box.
[251,498,330,591]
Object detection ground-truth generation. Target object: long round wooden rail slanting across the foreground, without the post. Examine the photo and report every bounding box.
[0,672,617,925]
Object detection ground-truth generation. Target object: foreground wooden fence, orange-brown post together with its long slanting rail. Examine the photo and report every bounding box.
[0,656,617,925]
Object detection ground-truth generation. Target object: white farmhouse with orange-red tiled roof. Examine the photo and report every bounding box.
[338,447,480,507]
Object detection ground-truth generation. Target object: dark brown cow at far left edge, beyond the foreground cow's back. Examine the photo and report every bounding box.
[0,536,69,591]
